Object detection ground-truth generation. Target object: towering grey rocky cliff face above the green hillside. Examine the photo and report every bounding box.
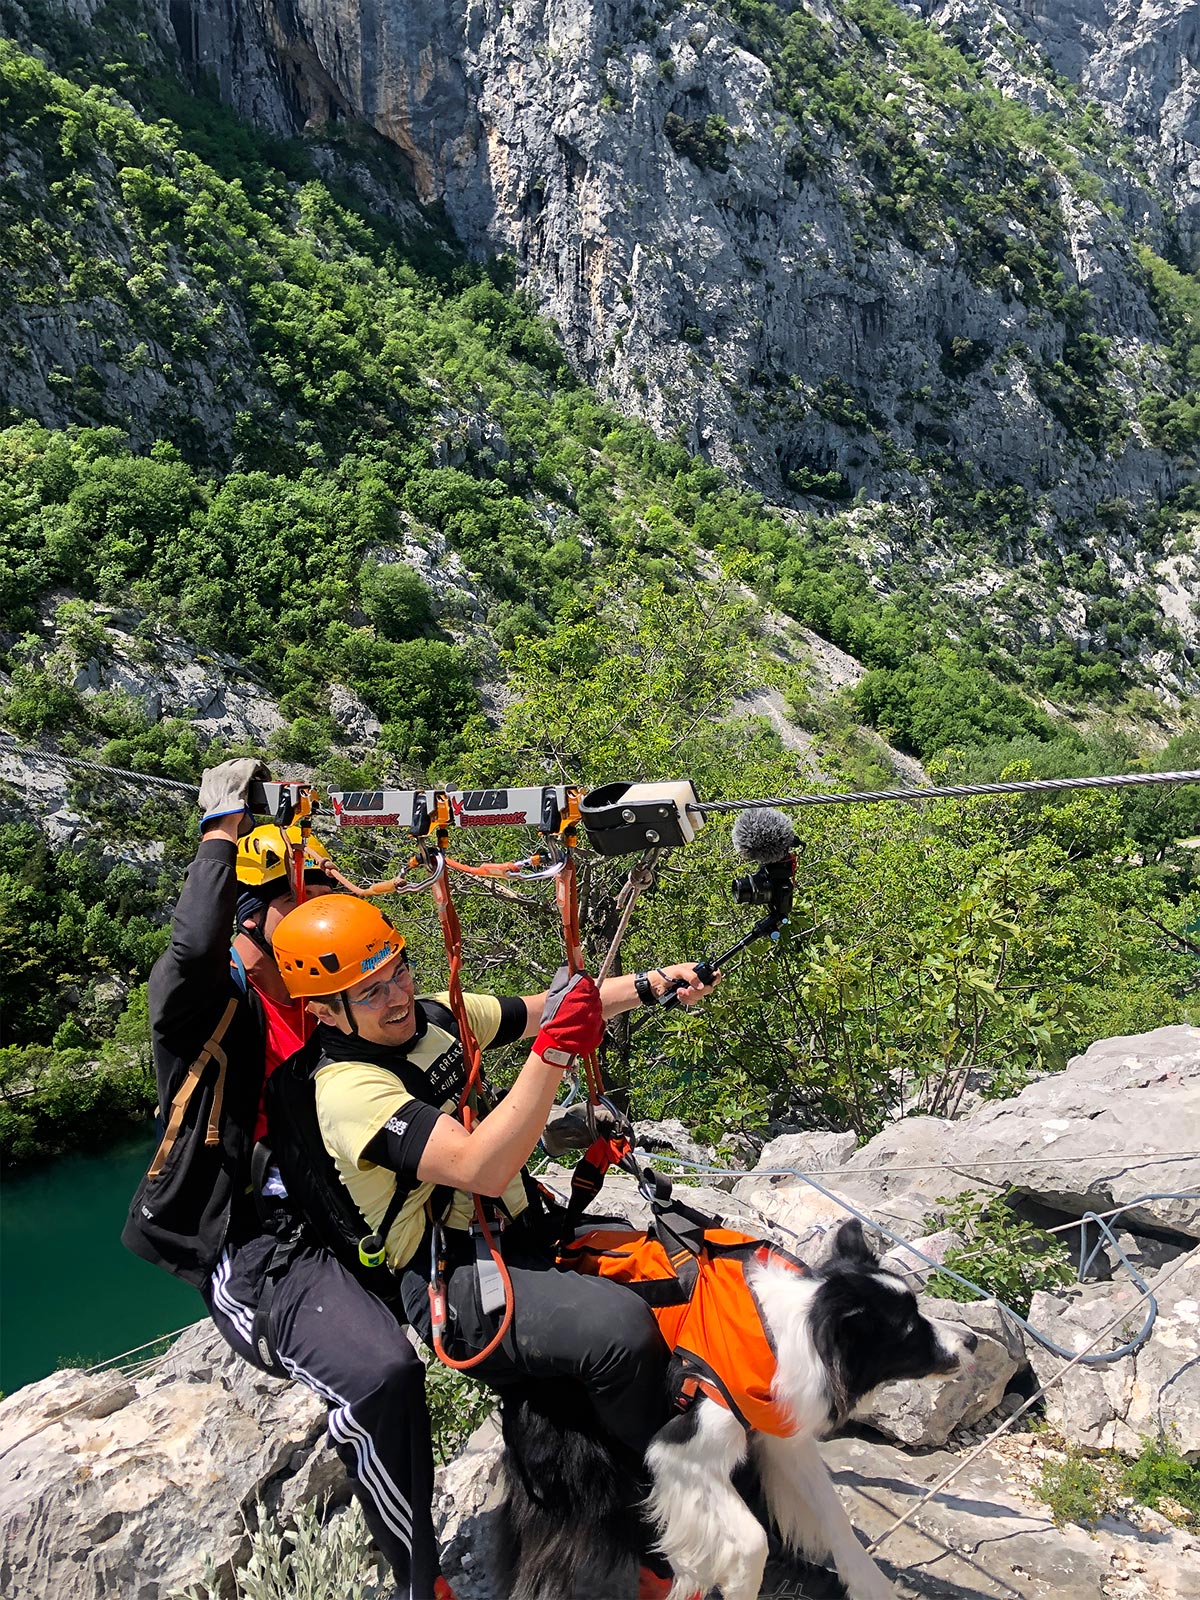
[152,0,1200,668]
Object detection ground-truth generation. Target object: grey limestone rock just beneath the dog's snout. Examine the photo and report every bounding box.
[854,1298,1026,1448]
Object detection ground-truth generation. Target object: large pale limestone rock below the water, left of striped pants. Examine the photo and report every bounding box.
[0,1323,329,1600]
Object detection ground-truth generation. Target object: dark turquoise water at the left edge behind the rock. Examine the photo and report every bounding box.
[0,1125,205,1394]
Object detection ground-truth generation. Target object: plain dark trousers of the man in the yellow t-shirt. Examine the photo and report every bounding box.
[403,1229,670,1464]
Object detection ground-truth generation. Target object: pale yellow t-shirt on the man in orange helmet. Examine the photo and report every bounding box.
[314,994,528,1269]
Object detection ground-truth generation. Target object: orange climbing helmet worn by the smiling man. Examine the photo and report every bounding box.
[270,894,405,1000]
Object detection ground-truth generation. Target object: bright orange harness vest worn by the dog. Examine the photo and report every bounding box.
[558,1202,808,1438]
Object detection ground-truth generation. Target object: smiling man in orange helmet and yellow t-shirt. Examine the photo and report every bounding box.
[272,896,723,1587]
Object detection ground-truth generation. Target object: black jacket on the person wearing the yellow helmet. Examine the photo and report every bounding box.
[122,838,266,1288]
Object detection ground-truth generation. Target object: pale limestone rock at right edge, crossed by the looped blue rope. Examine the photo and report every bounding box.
[1029,1250,1200,1459]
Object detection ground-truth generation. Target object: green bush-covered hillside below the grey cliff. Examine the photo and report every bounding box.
[0,0,1200,1154]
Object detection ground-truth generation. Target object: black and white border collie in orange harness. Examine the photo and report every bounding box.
[494,1221,976,1600]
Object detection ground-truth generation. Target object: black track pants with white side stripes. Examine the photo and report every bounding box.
[208,1237,438,1600]
